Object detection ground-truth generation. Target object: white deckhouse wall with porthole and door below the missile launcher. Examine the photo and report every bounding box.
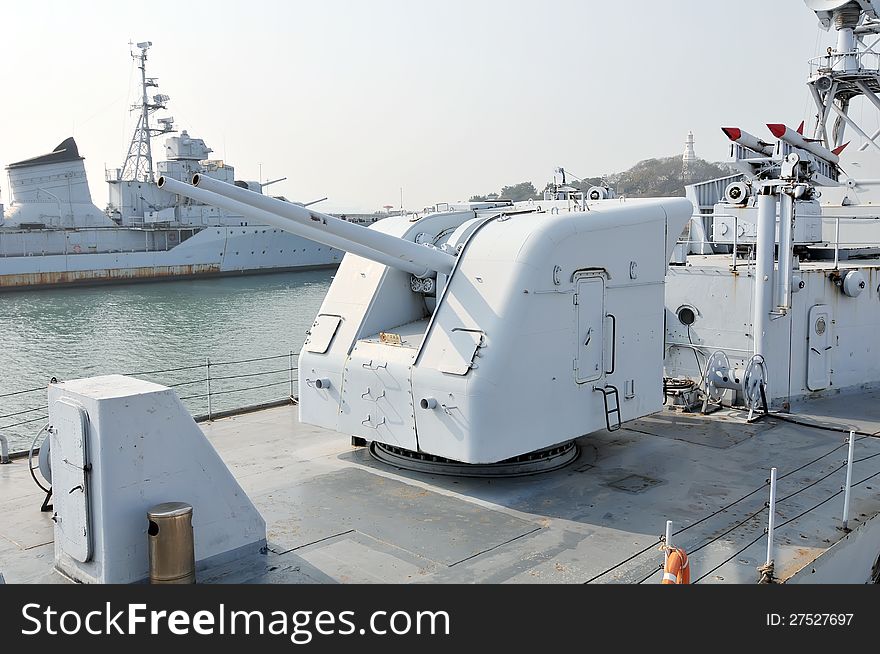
[665,262,880,403]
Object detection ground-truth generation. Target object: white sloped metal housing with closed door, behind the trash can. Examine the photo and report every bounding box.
[49,375,266,583]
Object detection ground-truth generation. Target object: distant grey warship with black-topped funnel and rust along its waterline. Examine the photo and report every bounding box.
[0,41,385,292]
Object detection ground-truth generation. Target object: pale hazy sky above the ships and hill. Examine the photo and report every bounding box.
[0,0,836,211]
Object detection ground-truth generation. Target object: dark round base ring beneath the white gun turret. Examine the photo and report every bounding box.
[370,441,578,478]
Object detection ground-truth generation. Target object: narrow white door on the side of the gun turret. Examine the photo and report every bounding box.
[574,276,605,384]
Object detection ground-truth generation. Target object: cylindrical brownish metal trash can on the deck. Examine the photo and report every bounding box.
[147,502,196,584]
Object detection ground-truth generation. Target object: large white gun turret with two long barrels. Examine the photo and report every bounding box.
[159,175,692,463]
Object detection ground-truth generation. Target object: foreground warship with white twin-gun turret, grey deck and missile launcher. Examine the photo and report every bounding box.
[0,0,880,584]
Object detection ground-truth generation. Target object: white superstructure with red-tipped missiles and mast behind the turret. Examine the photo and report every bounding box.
[666,0,880,407]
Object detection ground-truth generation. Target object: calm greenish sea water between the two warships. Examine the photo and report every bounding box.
[0,270,334,451]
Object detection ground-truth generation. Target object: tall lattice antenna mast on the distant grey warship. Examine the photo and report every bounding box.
[120,41,175,182]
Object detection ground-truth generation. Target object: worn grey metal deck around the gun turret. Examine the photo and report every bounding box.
[0,391,880,583]
